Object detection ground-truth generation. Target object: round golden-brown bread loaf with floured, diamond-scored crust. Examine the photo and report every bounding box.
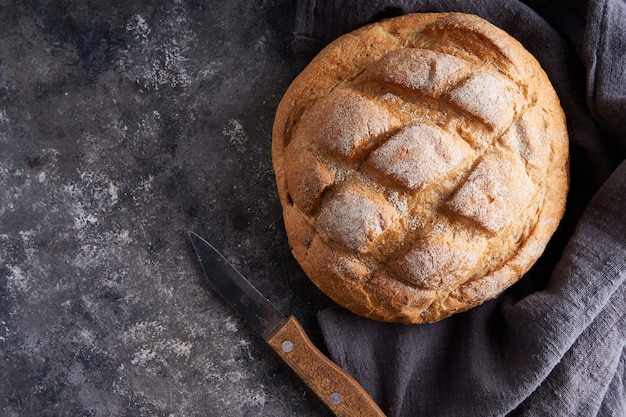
[272,13,569,323]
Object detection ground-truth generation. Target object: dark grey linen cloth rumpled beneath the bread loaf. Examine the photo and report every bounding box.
[293,0,626,416]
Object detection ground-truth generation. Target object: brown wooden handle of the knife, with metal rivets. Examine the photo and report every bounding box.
[267,316,385,417]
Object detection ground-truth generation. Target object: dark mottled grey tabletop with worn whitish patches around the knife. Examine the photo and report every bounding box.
[0,0,329,417]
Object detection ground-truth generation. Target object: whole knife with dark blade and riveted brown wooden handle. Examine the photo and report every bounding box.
[189,231,385,417]
